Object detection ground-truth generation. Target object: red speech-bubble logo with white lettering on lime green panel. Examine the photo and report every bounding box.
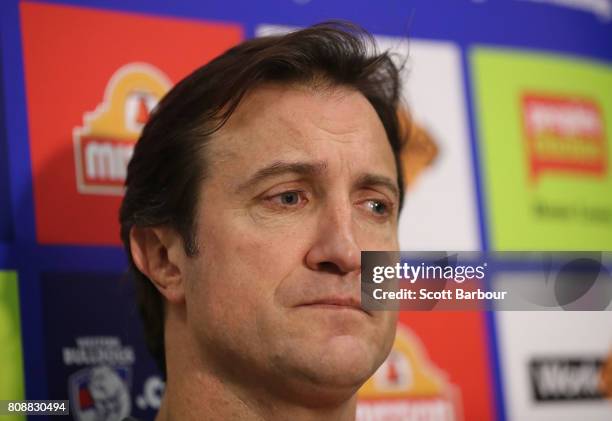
[522,93,607,182]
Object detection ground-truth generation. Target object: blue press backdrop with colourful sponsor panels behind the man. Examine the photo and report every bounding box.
[0,0,612,421]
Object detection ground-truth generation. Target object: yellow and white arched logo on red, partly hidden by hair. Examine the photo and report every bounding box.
[73,63,171,195]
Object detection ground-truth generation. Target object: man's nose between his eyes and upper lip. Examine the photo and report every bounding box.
[306,204,361,275]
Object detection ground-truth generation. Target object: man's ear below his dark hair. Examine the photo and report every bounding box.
[130,227,186,303]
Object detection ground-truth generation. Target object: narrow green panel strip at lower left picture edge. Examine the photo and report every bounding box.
[0,272,26,421]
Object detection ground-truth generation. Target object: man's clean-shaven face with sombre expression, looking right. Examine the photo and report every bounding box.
[185,85,399,400]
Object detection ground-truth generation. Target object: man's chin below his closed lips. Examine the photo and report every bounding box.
[262,309,393,398]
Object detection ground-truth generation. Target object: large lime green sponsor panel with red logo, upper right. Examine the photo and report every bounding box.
[470,48,612,250]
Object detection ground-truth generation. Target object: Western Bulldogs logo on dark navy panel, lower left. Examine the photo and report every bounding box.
[62,336,135,421]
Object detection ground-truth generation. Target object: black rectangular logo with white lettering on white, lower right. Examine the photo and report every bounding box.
[529,357,603,402]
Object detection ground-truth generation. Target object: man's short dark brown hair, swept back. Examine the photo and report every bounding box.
[119,22,404,374]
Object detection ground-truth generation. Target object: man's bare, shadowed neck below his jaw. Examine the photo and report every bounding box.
[155,313,356,421]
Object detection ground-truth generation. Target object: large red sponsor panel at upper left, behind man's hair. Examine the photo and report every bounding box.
[20,3,243,245]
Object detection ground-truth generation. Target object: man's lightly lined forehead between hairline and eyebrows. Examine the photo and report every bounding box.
[213,84,389,156]
